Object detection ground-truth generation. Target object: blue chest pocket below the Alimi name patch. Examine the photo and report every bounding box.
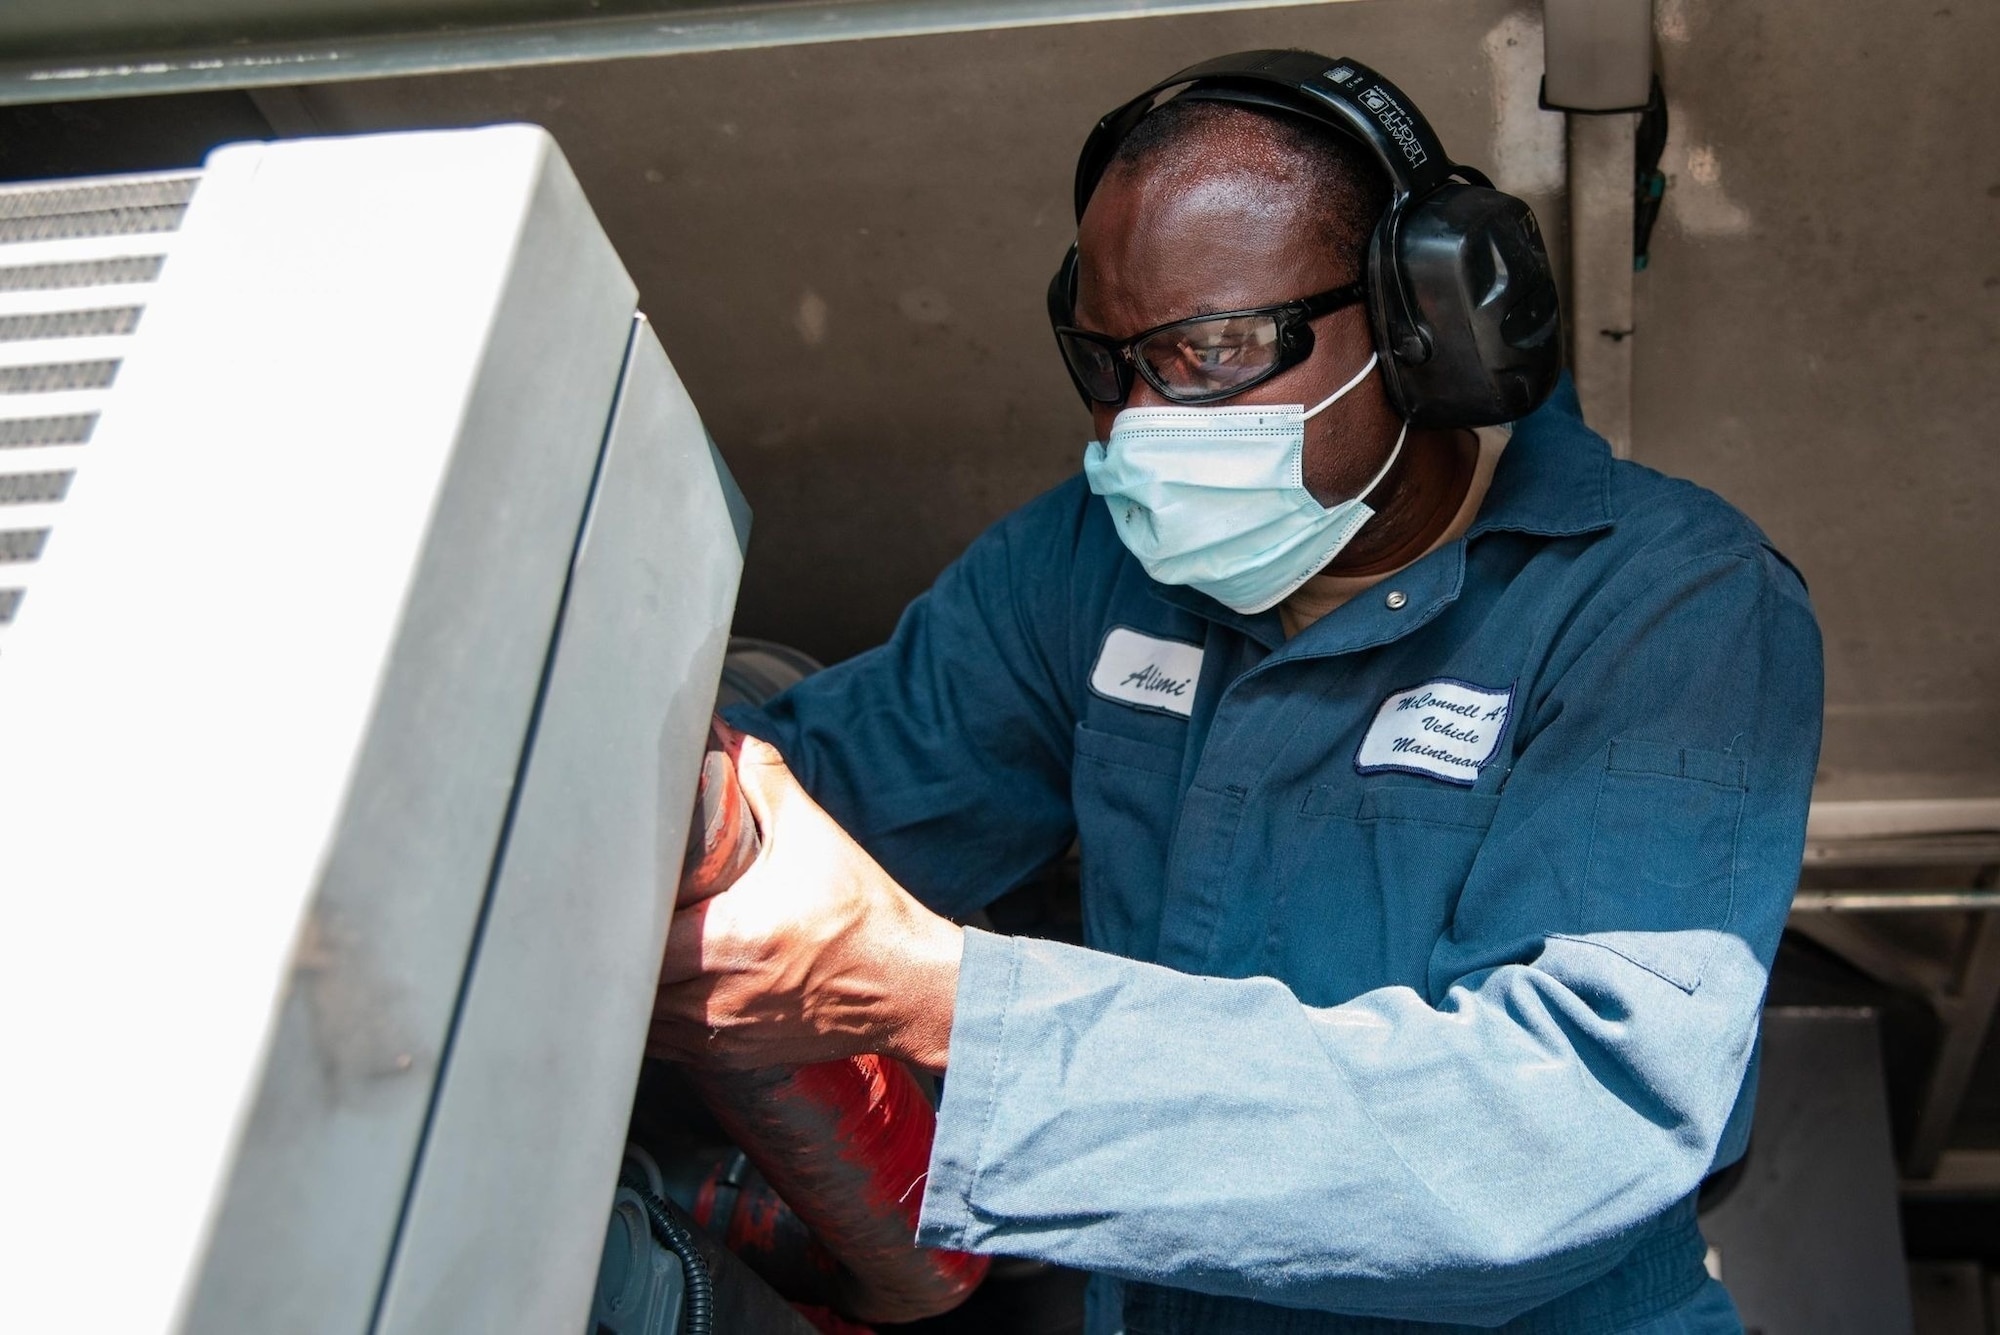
[1070,723,1182,959]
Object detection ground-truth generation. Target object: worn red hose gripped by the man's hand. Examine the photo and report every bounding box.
[680,719,988,1321]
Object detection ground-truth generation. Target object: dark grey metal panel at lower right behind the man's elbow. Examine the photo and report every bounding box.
[1702,1007,1910,1335]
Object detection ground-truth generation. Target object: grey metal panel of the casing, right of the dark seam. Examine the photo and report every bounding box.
[376,322,742,1335]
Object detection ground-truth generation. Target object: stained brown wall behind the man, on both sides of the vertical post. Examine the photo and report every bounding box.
[15,0,2000,795]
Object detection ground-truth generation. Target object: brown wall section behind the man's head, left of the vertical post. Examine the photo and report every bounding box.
[242,0,1564,662]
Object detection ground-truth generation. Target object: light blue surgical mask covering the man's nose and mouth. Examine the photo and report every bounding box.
[1084,347,1410,614]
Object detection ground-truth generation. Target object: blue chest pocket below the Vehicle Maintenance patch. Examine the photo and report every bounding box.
[1266,783,1500,1005]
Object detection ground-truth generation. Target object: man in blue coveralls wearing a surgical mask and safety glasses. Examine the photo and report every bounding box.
[654,49,1820,1335]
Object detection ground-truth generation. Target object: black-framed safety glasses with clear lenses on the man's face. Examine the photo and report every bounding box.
[1056,282,1366,404]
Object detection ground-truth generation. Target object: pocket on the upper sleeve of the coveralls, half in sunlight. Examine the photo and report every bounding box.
[1582,737,1748,991]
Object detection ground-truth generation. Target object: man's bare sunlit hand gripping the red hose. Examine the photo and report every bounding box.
[646,737,964,1071]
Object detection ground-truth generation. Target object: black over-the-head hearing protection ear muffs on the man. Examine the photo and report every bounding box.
[1048,50,1562,426]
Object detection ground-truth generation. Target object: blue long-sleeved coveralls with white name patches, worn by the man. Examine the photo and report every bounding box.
[734,382,1820,1335]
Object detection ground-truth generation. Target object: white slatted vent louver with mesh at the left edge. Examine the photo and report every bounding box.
[0,172,200,652]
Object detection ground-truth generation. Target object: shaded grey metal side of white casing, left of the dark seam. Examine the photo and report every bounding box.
[184,132,634,1335]
